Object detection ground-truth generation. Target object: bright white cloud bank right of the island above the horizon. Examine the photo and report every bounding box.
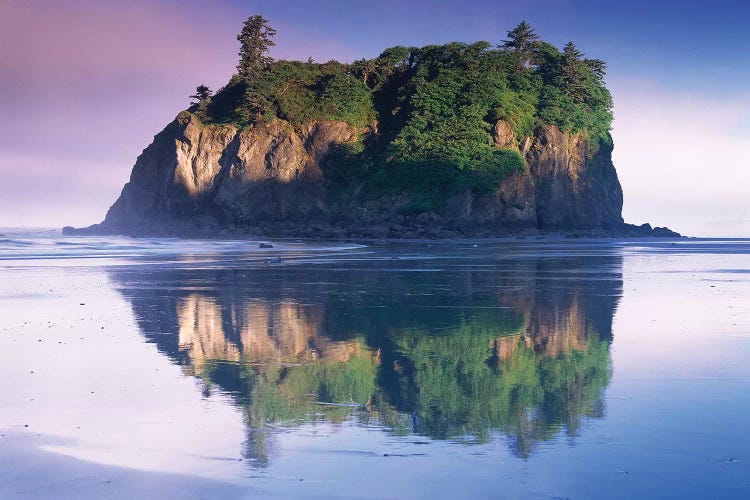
[612,80,750,236]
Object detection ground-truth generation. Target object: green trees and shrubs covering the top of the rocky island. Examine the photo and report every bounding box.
[190,16,612,208]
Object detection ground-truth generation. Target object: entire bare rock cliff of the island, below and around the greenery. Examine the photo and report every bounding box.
[70,112,636,237]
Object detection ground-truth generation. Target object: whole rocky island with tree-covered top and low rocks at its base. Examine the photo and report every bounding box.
[64,16,677,238]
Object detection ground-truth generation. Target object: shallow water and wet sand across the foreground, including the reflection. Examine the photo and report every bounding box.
[0,230,750,498]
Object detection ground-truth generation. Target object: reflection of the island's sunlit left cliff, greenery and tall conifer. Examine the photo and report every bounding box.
[169,292,377,466]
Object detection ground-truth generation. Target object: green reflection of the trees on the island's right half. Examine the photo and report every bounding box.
[383,322,609,456]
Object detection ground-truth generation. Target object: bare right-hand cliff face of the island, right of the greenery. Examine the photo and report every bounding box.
[447,121,623,230]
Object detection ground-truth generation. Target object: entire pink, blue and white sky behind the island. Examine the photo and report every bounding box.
[0,0,750,237]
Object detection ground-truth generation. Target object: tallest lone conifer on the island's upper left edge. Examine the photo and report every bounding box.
[237,15,276,84]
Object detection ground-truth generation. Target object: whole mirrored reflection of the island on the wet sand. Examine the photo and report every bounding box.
[112,252,622,465]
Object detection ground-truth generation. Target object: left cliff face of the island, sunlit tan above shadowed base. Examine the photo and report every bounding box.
[98,113,356,233]
